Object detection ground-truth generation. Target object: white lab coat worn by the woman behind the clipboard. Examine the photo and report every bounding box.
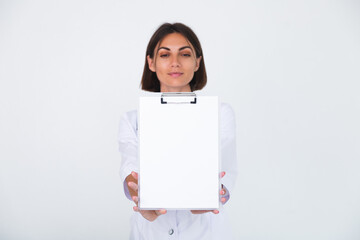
[118,103,237,240]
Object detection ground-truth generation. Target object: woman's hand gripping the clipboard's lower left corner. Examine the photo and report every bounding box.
[126,172,166,222]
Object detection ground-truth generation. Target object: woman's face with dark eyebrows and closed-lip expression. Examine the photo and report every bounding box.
[147,33,201,92]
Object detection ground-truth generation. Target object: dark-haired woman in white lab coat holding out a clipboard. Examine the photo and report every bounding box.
[119,23,237,240]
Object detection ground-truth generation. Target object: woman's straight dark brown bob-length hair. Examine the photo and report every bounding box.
[141,23,207,92]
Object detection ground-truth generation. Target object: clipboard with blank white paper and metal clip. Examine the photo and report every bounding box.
[138,93,220,210]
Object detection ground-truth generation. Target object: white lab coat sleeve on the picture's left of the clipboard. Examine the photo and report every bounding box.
[118,111,139,200]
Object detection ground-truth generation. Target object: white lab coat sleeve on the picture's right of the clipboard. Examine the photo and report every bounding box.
[220,103,238,199]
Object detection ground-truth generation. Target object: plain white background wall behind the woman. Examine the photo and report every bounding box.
[0,0,360,240]
